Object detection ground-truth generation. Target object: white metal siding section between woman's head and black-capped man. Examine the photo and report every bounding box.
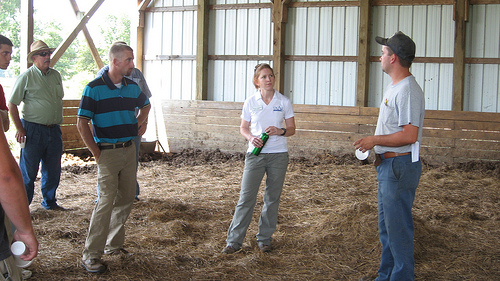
[283,7,359,106]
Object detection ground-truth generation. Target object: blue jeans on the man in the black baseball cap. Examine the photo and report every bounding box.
[376,154,422,281]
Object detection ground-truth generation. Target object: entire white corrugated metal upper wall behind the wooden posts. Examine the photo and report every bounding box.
[144,0,500,112]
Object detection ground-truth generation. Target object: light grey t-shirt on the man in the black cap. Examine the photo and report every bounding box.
[374,75,425,154]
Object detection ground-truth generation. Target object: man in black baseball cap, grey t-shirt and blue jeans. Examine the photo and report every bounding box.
[354,31,425,281]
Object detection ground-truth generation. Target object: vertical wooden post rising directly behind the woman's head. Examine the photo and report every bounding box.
[272,0,291,93]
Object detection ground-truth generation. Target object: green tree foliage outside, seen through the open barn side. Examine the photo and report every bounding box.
[0,0,130,95]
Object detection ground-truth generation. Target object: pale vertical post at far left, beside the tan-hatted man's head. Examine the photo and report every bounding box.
[19,0,34,72]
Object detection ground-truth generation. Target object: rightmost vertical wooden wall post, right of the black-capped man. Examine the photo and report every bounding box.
[451,0,469,111]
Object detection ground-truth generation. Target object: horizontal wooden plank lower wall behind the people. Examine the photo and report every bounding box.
[62,100,500,164]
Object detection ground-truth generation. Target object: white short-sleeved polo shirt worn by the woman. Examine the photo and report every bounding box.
[241,89,295,153]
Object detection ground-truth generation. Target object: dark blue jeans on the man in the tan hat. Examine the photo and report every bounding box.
[19,119,63,209]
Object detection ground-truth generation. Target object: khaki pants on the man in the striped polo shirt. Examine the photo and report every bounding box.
[83,145,137,260]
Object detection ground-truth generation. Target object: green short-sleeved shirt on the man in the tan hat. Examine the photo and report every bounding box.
[10,65,64,125]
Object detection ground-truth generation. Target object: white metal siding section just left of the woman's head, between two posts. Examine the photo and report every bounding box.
[207,2,273,102]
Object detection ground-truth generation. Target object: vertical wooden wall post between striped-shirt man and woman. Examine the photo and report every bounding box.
[196,0,209,100]
